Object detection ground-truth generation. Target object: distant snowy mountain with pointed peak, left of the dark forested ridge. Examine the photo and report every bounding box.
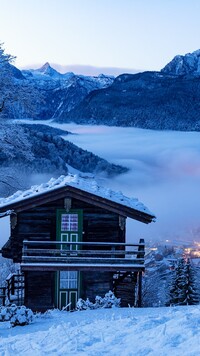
[19,62,114,119]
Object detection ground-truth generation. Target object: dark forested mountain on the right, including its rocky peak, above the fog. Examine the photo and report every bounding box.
[58,50,200,131]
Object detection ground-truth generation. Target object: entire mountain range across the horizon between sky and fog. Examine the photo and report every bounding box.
[4,50,200,131]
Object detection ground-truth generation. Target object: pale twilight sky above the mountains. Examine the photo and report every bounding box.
[0,0,200,74]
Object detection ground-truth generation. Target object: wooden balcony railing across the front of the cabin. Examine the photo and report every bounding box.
[21,240,145,271]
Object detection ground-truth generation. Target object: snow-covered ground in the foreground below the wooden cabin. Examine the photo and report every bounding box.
[0,306,200,356]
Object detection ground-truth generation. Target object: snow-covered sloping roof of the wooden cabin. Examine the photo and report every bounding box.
[0,174,154,221]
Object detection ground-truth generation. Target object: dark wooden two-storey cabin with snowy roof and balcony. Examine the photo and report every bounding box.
[0,175,155,311]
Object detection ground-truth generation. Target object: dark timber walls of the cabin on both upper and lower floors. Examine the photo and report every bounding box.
[3,193,138,311]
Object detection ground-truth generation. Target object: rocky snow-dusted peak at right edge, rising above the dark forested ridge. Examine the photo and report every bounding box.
[161,49,200,75]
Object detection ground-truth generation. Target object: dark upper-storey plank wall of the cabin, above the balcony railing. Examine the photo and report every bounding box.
[3,195,125,262]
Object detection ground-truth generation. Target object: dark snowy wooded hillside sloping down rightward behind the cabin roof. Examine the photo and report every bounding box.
[0,123,128,195]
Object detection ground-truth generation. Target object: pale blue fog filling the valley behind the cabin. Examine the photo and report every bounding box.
[1,121,200,243]
